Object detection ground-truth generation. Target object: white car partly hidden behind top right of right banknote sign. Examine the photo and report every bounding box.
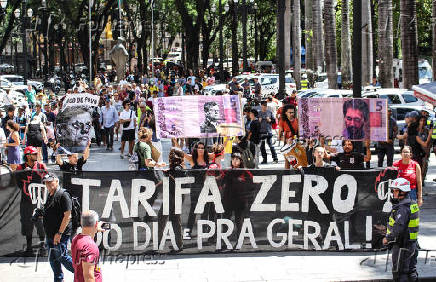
[362,88,425,106]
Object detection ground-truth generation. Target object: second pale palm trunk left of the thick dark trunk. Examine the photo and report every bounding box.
[323,0,338,89]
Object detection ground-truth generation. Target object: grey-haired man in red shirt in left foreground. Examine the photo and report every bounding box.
[71,210,103,282]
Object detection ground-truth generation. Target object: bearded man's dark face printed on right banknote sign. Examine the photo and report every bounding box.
[342,99,369,140]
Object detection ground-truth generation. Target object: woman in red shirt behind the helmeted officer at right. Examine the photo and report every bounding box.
[393,146,422,206]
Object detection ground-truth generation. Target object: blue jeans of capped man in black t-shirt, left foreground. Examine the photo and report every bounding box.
[46,235,74,282]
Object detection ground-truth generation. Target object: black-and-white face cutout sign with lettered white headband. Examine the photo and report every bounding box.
[56,93,100,153]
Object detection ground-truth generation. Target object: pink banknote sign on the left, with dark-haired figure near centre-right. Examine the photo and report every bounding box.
[153,95,244,138]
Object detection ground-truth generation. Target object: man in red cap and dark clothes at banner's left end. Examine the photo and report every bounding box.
[15,146,47,255]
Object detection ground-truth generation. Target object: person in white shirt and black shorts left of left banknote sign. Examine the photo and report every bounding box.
[120,100,136,159]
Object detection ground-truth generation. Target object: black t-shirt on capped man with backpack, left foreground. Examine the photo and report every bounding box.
[43,187,72,239]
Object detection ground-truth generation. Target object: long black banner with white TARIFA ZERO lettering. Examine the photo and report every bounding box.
[0,168,397,256]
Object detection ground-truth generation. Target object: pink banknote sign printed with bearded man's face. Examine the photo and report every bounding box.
[298,98,388,141]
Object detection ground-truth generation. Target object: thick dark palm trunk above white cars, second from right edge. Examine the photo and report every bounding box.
[400,0,419,89]
